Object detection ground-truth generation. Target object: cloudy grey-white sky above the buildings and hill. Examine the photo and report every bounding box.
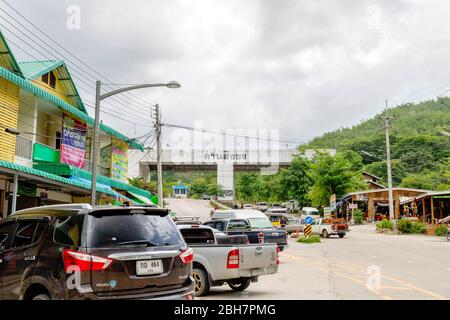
[0,0,450,149]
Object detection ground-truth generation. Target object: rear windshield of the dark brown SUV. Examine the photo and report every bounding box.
[87,214,184,248]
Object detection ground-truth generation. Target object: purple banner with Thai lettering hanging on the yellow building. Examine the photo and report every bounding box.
[61,113,87,168]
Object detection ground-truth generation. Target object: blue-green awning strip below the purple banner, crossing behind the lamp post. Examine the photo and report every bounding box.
[33,162,152,199]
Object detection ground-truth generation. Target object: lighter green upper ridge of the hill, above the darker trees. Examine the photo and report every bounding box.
[308,98,450,149]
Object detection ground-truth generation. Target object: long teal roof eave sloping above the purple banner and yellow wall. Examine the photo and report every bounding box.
[0,67,144,151]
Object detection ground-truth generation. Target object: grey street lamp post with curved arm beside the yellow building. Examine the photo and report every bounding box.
[91,81,181,205]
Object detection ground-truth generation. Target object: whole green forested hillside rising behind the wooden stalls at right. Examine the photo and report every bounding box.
[307,98,450,190]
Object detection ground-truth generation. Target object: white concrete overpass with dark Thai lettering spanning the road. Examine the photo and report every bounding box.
[128,149,336,200]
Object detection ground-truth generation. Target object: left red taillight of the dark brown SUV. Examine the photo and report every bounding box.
[63,250,112,272]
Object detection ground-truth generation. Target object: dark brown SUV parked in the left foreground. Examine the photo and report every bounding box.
[0,204,194,300]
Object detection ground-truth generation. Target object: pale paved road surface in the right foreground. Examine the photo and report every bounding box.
[199,225,450,300]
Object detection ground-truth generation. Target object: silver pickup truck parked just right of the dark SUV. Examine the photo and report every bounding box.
[178,225,279,296]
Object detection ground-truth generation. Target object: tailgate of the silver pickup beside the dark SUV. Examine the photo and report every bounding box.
[239,244,277,269]
